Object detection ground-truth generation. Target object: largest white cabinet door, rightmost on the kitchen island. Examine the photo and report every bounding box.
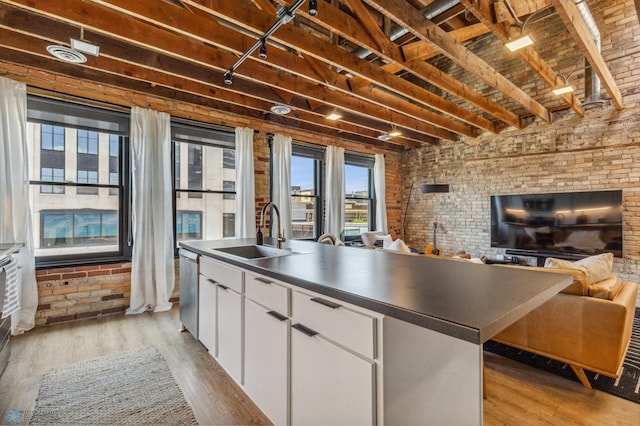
[291,325,375,425]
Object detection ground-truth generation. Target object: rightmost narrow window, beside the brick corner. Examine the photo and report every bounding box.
[343,154,375,241]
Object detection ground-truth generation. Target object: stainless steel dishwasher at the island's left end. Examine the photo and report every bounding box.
[178,248,200,339]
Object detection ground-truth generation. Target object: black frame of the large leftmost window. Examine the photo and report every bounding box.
[27,95,132,268]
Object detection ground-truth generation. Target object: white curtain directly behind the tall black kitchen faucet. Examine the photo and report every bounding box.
[271,135,291,239]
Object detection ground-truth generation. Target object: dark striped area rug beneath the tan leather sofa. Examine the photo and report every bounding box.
[484,308,640,404]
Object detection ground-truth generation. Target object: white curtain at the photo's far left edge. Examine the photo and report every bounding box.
[0,77,38,335]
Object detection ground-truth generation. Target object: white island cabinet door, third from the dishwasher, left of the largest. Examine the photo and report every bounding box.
[244,298,290,425]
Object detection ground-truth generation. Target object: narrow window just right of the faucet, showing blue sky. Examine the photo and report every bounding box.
[291,145,323,240]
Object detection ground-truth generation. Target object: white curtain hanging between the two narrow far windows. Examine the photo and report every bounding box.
[324,145,344,238]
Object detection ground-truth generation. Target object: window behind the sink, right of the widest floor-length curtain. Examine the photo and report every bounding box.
[171,122,236,250]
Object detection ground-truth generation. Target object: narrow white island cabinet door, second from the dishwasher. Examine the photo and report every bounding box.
[217,284,242,384]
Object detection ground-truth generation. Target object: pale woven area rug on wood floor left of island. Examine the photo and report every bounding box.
[30,346,198,425]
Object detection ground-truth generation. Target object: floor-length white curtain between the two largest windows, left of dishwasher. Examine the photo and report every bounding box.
[127,107,175,314]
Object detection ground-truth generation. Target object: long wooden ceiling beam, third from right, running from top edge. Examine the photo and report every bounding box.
[365,0,551,122]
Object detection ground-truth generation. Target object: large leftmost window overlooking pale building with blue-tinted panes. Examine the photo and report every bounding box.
[27,96,130,266]
